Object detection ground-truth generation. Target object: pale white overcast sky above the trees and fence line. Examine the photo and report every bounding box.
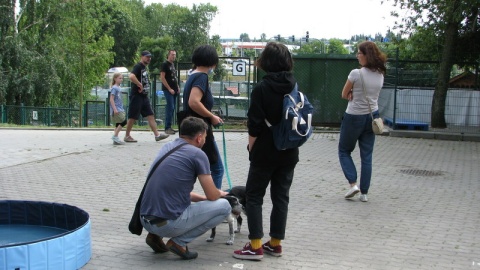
[144,0,402,39]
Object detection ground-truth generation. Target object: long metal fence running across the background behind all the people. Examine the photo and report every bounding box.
[0,55,480,133]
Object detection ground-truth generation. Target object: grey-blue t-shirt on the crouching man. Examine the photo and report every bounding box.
[140,138,211,220]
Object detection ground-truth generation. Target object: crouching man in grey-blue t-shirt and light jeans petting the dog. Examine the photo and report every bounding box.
[140,117,231,260]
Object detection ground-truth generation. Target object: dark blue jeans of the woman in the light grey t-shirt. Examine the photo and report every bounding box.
[338,111,378,194]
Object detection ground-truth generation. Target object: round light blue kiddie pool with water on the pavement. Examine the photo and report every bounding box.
[0,200,92,270]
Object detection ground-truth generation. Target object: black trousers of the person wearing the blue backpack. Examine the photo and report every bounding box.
[245,161,296,240]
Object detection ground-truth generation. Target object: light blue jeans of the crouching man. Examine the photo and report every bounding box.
[140,199,232,247]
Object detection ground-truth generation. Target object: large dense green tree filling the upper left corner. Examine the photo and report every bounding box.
[0,0,113,126]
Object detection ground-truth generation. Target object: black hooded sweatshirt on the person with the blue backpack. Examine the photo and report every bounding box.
[247,71,298,166]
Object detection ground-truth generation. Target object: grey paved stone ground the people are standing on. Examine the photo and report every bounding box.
[0,129,480,270]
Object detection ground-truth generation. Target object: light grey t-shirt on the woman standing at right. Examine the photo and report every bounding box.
[346,67,383,115]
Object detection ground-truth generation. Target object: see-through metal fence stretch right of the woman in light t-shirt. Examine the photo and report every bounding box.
[378,60,480,133]
